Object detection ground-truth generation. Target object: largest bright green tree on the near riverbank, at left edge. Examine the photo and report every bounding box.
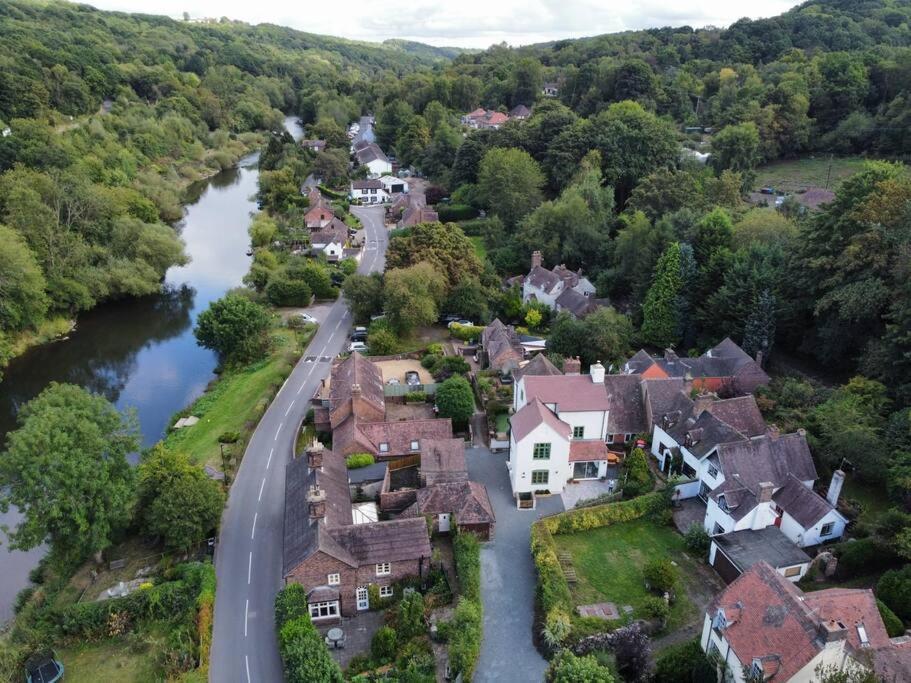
[0,382,139,560]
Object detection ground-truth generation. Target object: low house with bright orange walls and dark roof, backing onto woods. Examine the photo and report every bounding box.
[623,337,769,396]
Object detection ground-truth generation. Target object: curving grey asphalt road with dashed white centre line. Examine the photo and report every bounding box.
[209,207,387,683]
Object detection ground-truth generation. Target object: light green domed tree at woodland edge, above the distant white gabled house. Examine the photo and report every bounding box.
[478,148,544,228]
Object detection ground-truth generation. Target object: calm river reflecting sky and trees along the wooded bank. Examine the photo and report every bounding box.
[0,117,303,623]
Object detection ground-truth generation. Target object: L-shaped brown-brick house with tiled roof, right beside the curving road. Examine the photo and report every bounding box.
[282,443,431,624]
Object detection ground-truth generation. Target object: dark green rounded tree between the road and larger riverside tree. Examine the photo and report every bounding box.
[138,444,225,551]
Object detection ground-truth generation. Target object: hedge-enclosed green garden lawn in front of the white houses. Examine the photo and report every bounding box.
[554,519,705,630]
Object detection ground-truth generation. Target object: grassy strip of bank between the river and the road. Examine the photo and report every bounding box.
[158,326,316,470]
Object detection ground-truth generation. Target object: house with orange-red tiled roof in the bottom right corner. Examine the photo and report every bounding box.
[700,562,899,683]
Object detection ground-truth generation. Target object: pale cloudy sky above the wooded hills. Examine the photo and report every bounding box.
[86,0,798,48]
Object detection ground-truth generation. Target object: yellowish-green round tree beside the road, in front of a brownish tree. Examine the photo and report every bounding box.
[383,262,446,335]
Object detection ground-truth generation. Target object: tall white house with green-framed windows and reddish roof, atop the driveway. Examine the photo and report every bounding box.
[507,359,617,495]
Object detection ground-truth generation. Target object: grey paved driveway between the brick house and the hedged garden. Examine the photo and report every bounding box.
[466,448,563,683]
